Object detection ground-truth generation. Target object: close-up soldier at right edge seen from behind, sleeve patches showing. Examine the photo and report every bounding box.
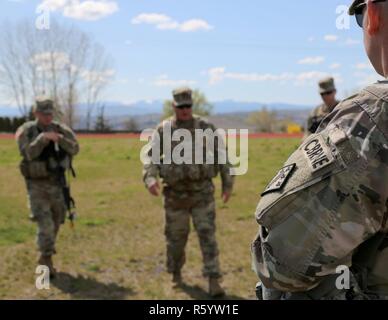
[252,1,388,300]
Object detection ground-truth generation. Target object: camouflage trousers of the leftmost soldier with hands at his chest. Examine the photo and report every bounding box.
[27,180,66,256]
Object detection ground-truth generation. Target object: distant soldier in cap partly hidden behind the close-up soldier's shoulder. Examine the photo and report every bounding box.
[305,78,339,137]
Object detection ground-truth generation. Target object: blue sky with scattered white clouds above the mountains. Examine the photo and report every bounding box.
[0,0,378,105]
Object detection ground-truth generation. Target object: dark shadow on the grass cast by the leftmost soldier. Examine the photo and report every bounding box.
[51,272,135,300]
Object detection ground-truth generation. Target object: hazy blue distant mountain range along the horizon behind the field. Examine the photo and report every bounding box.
[0,100,313,129]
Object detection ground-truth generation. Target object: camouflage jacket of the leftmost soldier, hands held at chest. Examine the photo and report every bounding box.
[16,120,79,179]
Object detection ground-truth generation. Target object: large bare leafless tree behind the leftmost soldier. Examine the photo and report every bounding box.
[0,21,114,129]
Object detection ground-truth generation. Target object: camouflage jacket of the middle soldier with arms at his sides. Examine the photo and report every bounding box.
[143,116,234,192]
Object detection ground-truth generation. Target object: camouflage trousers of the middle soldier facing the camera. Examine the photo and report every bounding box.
[164,188,221,278]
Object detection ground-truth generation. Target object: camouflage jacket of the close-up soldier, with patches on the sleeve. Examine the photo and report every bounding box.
[252,81,388,295]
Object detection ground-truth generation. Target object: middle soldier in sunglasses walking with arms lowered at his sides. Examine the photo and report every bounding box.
[143,88,233,296]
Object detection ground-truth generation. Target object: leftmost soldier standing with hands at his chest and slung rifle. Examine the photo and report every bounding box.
[16,97,79,277]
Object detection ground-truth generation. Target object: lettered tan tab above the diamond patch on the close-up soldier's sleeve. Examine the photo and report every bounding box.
[302,136,335,172]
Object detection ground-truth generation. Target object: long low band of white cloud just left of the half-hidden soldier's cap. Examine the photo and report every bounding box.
[207,67,341,86]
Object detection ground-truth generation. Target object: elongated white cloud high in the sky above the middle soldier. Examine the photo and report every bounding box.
[132,13,213,32]
